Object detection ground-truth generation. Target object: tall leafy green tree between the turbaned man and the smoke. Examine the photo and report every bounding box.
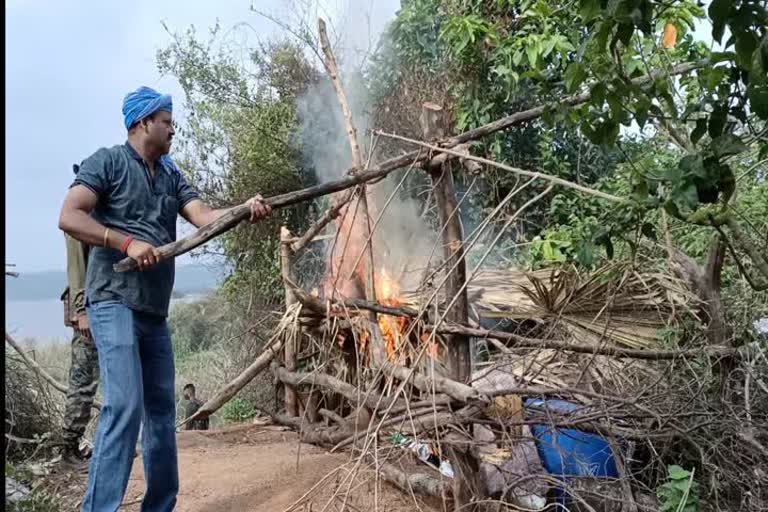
[157,26,316,300]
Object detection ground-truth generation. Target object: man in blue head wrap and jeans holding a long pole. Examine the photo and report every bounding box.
[59,87,271,512]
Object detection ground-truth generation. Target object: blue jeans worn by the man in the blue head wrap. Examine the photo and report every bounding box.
[82,301,179,512]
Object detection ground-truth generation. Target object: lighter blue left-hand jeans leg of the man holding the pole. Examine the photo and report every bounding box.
[82,301,144,512]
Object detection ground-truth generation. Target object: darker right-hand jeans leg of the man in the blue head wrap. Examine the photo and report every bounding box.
[136,313,179,512]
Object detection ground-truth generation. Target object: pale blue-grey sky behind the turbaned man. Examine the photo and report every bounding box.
[5,0,399,273]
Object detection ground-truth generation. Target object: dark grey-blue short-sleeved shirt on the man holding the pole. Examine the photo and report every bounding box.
[72,142,199,316]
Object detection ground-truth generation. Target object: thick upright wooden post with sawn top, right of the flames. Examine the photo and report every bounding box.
[419,103,472,383]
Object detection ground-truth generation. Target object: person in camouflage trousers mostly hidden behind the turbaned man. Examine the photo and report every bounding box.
[61,198,99,462]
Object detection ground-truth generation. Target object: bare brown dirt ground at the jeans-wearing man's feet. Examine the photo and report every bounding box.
[49,424,436,512]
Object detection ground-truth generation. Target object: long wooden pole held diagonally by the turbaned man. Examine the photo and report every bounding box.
[114,60,709,272]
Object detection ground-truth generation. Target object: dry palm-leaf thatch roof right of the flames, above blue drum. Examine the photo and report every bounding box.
[406,264,697,348]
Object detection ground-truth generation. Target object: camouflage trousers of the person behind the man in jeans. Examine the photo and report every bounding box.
[62,332,99,444]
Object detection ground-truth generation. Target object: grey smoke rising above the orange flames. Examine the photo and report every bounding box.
[297,0,439,294]
